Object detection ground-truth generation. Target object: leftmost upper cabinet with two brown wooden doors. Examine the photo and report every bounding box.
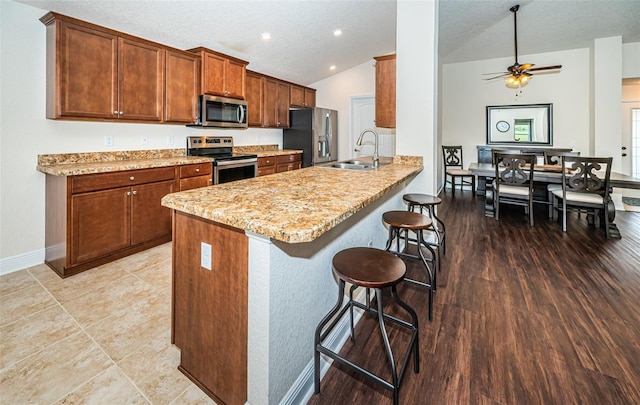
[40,13,164,122]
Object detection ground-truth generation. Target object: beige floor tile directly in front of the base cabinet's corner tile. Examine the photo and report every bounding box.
[63,275,152,327]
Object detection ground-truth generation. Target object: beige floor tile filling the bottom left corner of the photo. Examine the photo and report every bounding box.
[0,333,111,404]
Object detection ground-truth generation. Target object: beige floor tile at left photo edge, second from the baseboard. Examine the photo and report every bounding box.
[0,284,57,326]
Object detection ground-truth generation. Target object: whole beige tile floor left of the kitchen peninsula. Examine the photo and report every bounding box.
[0,243,215,404]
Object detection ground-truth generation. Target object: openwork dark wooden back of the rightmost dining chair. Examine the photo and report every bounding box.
[562,155,613,200]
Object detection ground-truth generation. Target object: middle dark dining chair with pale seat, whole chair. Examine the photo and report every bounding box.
[493,152,537,226]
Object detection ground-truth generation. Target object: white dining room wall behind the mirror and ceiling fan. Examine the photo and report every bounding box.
[440,48,589,169]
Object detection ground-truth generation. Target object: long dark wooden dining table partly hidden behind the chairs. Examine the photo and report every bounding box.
[469,162,640,238]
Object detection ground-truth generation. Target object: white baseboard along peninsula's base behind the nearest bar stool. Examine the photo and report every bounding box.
[280,288,364,405]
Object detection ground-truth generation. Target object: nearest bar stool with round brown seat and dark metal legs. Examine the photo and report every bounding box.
[314,247,420,405]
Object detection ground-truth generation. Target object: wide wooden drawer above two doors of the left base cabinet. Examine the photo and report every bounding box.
[71,166,175,194]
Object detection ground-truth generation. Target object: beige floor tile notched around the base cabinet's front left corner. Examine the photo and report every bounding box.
[31,263,128,302]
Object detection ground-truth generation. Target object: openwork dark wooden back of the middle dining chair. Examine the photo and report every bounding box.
[494,152,537,194]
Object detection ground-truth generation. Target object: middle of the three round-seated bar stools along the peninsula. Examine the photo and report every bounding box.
[382,211,436,321]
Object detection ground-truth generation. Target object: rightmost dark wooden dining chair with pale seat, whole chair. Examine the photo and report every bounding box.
[552,156,613,239]
